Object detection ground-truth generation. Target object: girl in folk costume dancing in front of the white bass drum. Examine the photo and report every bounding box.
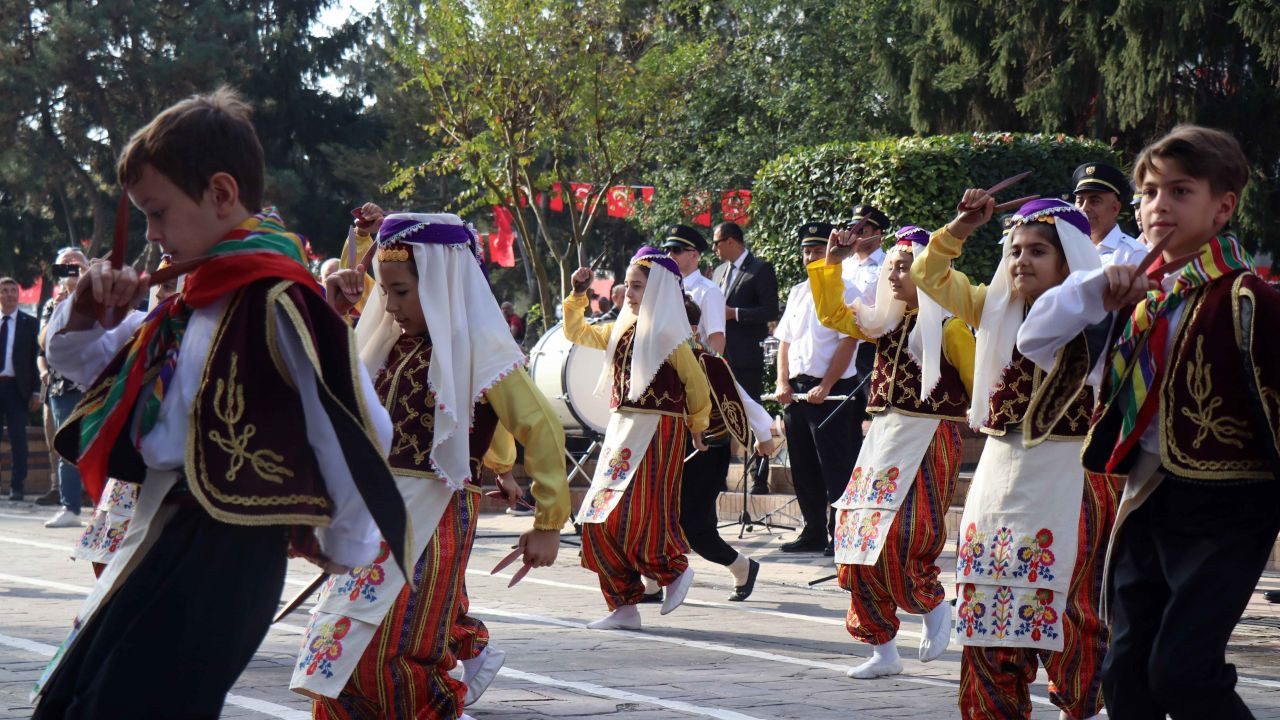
[564,247,710,629]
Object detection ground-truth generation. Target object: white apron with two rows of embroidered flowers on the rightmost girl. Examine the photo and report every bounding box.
[956,433,1084,651]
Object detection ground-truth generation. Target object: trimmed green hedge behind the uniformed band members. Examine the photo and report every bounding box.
[748,133,1133,288]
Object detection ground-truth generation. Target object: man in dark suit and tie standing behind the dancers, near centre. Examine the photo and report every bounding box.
[712,223,778,495]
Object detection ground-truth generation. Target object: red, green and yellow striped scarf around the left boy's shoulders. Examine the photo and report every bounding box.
[79,209,319,497]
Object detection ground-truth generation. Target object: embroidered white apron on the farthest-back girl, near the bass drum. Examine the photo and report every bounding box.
[577,410,662,524]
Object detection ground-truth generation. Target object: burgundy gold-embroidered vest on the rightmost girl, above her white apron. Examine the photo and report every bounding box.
[982,338,1093,442]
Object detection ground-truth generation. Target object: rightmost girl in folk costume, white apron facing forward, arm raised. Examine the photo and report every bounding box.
[911,190,1115,719]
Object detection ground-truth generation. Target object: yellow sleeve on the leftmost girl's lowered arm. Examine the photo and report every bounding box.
[485,368,570,530]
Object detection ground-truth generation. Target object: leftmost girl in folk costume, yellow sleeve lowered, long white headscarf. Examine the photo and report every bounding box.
[291,213,568,720]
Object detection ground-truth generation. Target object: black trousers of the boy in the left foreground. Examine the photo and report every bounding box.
[32,507,288,720]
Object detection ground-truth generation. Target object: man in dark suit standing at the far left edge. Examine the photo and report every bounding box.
[0,278,40,500]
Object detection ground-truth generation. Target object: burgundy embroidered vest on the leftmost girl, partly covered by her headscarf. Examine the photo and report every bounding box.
[374,336,498,480]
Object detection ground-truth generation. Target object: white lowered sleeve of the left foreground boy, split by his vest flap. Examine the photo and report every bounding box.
[275,304,392,568]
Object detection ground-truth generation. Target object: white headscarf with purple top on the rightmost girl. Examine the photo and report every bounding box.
[969,200,1102,429]
